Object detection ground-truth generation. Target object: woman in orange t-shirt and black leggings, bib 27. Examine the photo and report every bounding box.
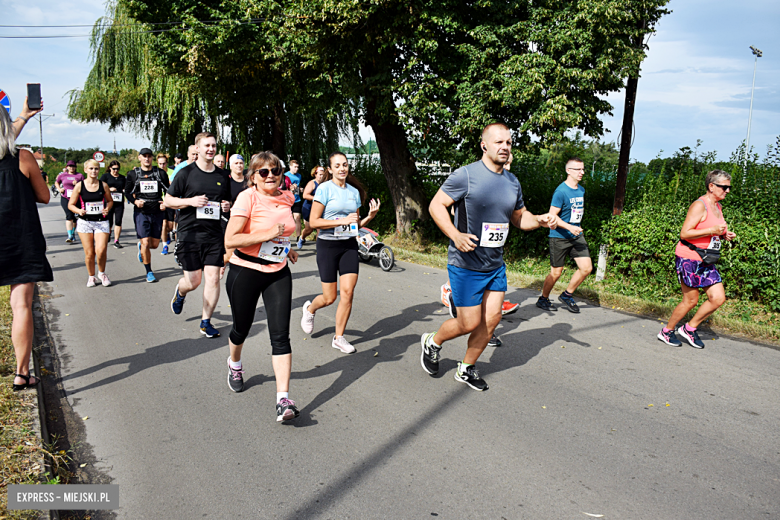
[225,152,299,422]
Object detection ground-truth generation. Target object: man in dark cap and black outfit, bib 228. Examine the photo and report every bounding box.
[125,148,169,282]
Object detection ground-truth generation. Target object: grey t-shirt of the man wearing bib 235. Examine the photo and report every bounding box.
[441,161,525,273]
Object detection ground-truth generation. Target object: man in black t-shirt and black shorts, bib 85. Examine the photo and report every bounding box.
[165,132,230,338]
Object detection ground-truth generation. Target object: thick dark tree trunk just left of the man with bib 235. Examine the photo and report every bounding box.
[366,98,429,233]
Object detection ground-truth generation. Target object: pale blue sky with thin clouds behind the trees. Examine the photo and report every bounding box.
[0,0,780,162]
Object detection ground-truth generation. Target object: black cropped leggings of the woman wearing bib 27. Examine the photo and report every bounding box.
[225,264,292,356]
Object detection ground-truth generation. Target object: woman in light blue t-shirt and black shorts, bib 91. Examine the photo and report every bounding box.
[301,152,379,354]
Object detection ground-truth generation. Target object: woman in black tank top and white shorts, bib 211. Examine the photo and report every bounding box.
[68,159,114,287]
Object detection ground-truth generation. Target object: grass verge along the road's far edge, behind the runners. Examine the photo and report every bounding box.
[385,236,780,344]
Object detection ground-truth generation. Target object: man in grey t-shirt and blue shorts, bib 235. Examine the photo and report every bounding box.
[420,123,558,391]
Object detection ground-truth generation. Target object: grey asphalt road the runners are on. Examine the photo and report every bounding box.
[40,201,780,520]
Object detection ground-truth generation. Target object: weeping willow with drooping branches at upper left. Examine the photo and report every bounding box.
[68,0,352,167]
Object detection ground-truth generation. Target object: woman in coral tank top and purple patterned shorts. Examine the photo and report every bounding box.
[658,170,737,348]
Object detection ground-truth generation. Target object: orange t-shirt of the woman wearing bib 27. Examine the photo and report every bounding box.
[230,187,295,273]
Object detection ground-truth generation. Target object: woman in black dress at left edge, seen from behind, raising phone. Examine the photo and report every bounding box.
[0,105,54,390]
